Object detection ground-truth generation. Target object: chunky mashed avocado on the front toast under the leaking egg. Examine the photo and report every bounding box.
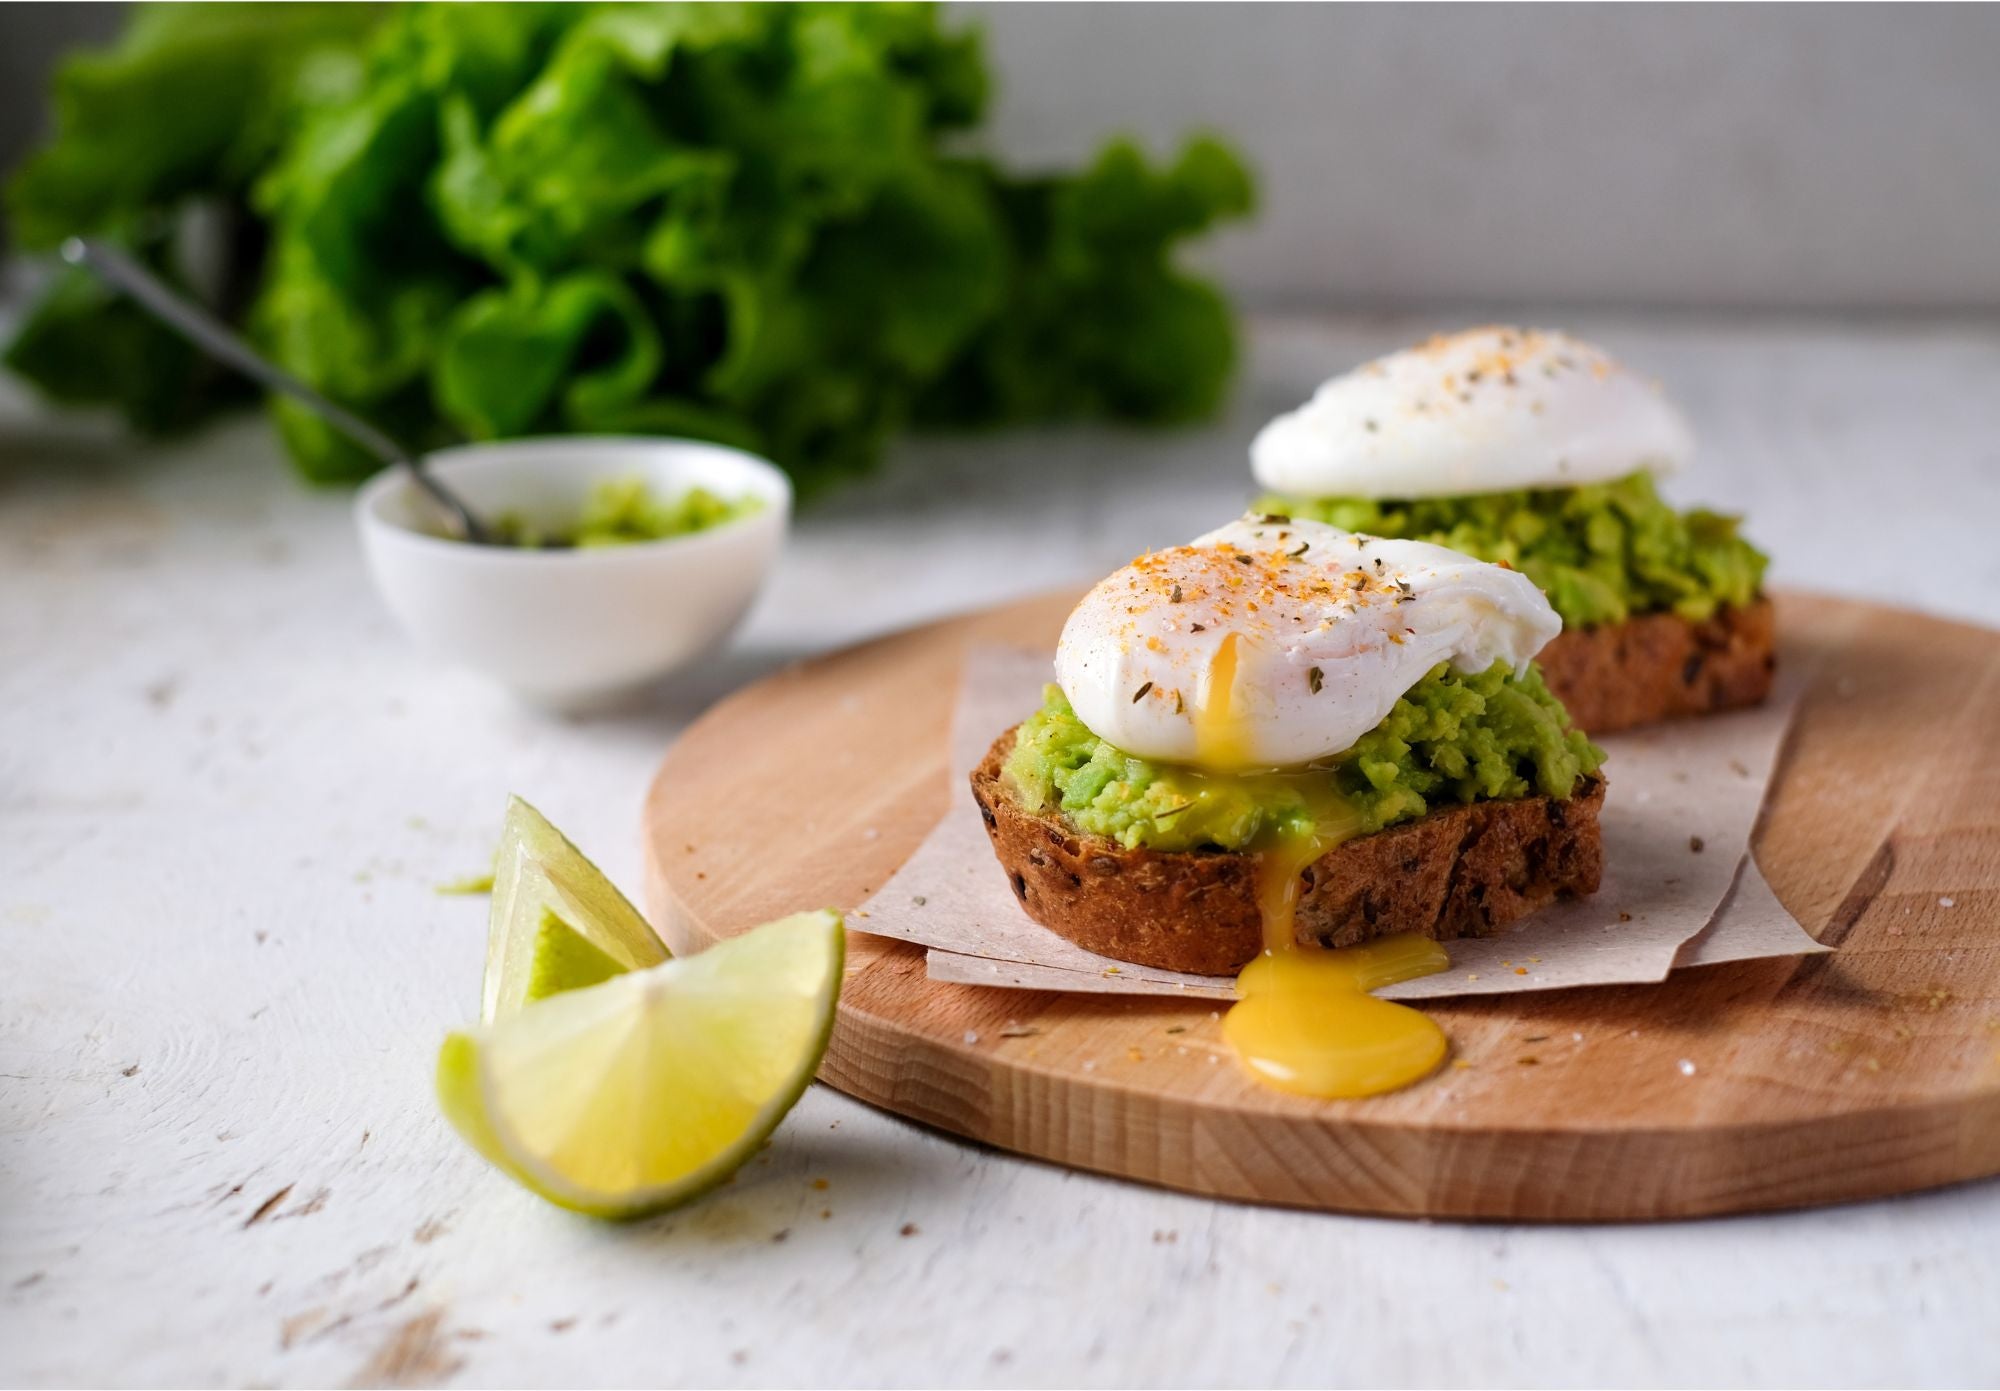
[1006,664,1604,849]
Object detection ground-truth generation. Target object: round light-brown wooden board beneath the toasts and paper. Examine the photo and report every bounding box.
[644,594,2000,1219]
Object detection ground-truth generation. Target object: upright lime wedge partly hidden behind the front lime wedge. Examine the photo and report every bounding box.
[480,797,668,1023]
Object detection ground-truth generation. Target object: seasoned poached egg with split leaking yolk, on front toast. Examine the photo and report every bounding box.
[1056,516,1562,773]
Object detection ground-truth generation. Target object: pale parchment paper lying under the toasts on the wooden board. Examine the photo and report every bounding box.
[848,646,1820,999]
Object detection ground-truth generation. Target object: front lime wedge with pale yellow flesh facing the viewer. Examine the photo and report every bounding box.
[438,911,846,1217]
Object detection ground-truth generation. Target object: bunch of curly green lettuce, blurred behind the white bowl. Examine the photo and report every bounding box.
[10,4,1252,490]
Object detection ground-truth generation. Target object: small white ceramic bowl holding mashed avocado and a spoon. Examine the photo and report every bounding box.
[354,436,792,709]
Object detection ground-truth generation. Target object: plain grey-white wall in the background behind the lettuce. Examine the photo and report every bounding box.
[0,4,2000,310]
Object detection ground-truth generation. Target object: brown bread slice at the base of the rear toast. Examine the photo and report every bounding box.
[1536,600,1778,735]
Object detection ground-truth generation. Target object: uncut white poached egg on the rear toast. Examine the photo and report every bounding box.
[1250,326,1694,500]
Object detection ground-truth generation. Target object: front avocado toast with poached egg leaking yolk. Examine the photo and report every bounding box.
[972,516,1604,973]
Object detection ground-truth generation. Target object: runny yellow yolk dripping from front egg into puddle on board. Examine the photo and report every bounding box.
[1194,634,1452,1097]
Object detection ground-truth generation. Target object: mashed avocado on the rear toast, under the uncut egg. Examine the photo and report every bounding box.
[1256,472,1770,628]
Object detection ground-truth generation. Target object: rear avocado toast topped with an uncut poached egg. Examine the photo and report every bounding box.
[1252,328,1776,733]
